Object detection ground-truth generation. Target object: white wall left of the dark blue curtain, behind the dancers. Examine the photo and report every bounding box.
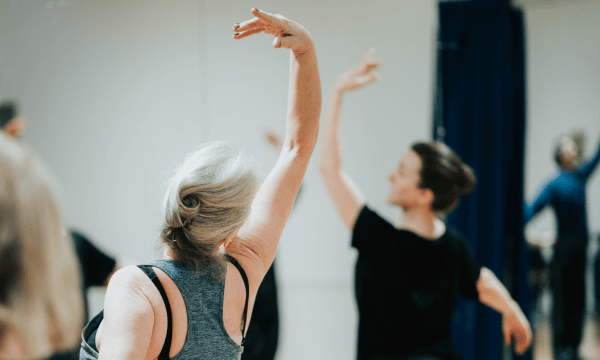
[0,0,437,360]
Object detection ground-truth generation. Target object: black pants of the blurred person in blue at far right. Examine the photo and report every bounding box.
[550,239,587,357]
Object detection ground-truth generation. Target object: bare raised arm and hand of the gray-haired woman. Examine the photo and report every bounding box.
[227,9,321,286]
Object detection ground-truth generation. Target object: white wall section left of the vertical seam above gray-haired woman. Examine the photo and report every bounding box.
[0,0,207,261]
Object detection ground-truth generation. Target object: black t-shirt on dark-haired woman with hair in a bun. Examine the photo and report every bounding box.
[352,206,481,360]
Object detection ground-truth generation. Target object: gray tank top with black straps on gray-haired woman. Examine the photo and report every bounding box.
[79,256,249,360]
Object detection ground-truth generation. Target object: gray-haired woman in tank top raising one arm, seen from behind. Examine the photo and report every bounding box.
[80,9,321,360]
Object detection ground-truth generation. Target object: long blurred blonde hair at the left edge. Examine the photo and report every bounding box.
[0,134,83,358]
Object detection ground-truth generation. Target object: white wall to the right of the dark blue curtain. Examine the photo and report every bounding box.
[522,0,600,245]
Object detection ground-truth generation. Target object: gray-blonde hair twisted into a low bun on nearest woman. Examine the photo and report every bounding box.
[161,141,260,282]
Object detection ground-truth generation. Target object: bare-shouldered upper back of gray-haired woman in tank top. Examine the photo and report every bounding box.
[91,259,246,360]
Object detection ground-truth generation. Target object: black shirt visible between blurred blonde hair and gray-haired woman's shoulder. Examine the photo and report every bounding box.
[49,231,116,360]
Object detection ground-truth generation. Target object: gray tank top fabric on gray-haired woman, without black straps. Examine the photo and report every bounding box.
[79,260,244,360]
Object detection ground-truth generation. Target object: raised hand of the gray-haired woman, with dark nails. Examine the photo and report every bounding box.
[233,8,313,56]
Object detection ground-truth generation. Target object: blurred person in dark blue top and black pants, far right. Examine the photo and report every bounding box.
[524,133,600,359]
